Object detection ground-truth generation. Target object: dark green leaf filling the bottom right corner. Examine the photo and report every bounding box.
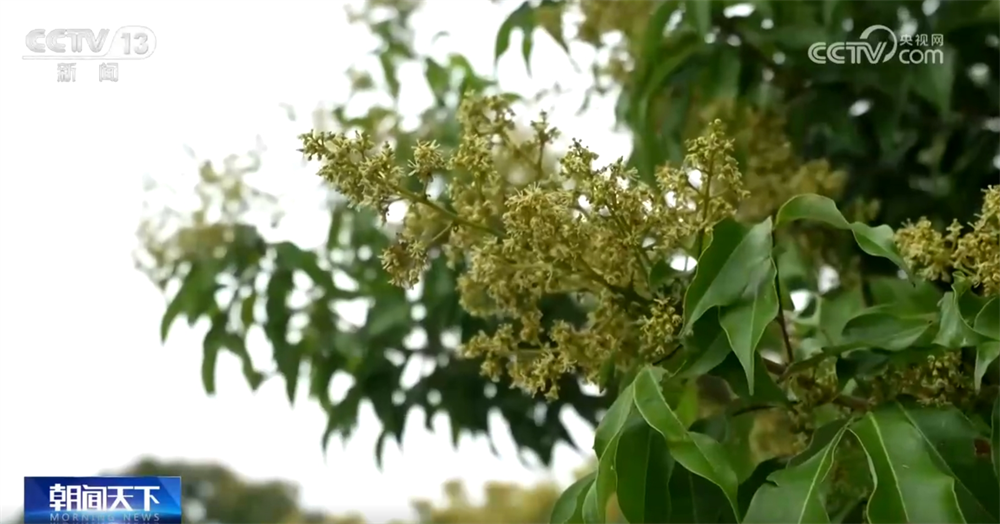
[893,404,1000,524]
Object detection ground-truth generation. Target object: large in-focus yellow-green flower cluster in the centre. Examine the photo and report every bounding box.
[302,97,746,397]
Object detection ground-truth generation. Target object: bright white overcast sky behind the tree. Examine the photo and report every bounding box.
[0,0,628,522]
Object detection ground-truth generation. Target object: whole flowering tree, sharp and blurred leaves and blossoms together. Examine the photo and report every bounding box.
[135,0,1000,524]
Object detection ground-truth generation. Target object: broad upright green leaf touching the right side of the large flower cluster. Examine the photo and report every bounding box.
[684,218,772,333]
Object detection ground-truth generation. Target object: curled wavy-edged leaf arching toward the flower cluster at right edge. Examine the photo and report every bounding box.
[774,194,913,280]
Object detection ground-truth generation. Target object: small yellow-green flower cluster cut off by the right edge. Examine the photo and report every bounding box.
[896,186,1000,296]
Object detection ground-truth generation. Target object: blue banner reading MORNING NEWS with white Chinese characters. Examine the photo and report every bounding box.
[24,477,181,524]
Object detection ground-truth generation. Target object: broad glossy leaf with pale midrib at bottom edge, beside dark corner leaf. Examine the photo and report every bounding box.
[851,406,965,524]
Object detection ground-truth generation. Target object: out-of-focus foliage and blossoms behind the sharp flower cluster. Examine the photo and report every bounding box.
[136,0,1000,474]
